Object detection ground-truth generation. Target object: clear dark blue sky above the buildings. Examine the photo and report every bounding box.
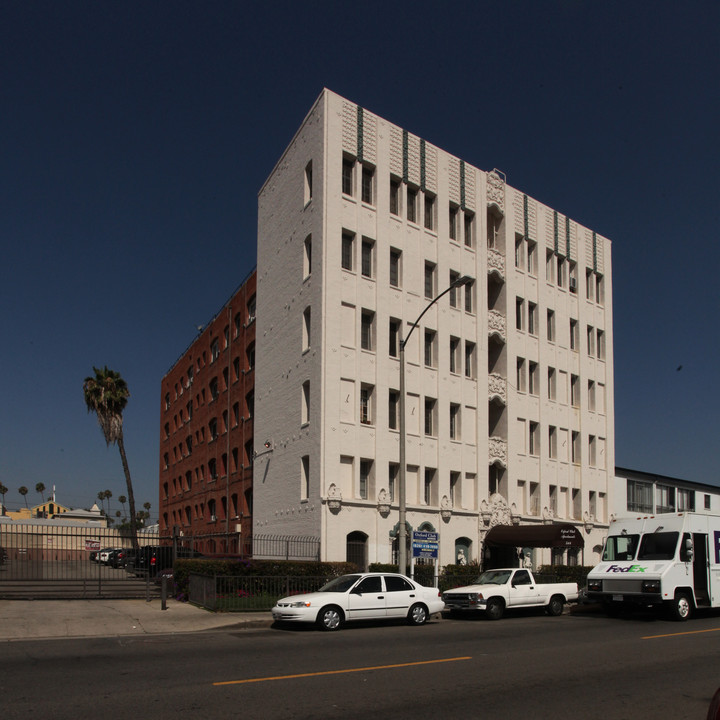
[0,0,720,516]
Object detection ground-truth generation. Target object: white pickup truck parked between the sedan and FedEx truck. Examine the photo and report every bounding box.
[442,568,578,620]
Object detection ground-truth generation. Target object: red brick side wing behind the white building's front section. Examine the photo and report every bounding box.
[160,272,256,552]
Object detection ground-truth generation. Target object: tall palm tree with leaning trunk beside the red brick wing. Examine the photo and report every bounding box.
[83,365,138,551]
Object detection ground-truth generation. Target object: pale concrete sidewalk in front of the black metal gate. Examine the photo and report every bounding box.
[0,600,272,642]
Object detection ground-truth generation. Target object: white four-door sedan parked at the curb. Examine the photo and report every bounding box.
[272,573,445,630]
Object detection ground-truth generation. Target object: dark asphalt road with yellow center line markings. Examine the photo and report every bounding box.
[0,613,720,720]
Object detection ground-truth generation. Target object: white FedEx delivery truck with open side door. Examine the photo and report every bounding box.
[587,512,720,620]
